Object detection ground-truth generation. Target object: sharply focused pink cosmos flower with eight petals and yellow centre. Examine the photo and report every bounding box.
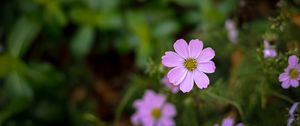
[162,39,216,92]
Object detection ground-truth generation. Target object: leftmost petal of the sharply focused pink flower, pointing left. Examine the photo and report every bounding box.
[162,51,184,67]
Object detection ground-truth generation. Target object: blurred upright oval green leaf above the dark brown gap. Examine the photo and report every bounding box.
[70,26,95,59]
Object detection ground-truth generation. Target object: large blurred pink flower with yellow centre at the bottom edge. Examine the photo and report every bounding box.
[131,90,176,126]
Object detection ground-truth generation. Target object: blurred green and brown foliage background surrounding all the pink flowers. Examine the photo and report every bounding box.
[0,0,300,126]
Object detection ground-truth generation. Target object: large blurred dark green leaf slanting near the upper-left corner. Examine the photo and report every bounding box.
[7,17,40,57]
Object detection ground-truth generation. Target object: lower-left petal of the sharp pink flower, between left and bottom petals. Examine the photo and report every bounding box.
[167,67,187,85]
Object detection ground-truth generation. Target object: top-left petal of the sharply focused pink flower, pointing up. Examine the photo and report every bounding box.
[173,39,189,59]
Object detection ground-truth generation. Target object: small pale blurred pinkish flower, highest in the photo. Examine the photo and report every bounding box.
[225,19,239,43]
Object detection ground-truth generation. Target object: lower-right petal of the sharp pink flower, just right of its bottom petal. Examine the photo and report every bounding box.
[193,70,209,89]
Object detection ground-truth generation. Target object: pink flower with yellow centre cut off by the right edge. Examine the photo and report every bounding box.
[278,55,300,89]
